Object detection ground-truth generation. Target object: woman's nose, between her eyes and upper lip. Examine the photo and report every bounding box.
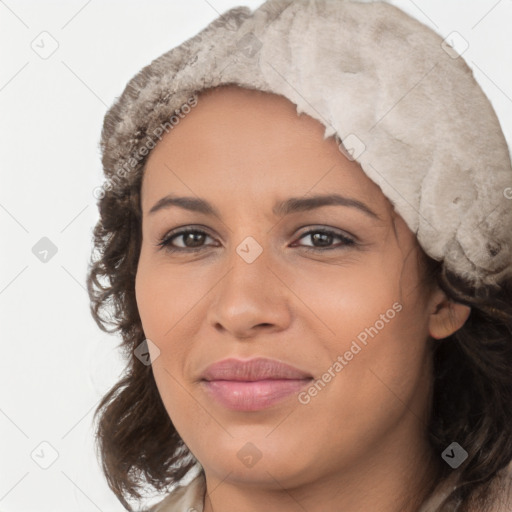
[207,243,293,339]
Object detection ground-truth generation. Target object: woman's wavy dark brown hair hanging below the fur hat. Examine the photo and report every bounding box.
[87,130,512,512]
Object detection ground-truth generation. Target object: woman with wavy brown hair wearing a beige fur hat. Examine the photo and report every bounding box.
[88,0,512,512]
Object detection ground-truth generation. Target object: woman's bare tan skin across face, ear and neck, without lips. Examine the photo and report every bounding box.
[136,86,470,512]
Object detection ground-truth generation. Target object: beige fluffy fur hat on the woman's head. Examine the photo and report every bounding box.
[101,0,512,287]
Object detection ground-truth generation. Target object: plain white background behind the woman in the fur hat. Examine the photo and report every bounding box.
[0,0,512,512]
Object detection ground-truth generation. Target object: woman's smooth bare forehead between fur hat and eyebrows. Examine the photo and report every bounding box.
[143,86,389,216]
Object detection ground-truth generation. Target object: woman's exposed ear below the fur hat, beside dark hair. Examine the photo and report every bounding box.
[428,288,471,339]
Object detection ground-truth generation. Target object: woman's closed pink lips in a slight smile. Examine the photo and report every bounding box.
[201,357,313,411]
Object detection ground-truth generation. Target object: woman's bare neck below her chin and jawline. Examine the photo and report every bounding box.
[204,420,440,512]
